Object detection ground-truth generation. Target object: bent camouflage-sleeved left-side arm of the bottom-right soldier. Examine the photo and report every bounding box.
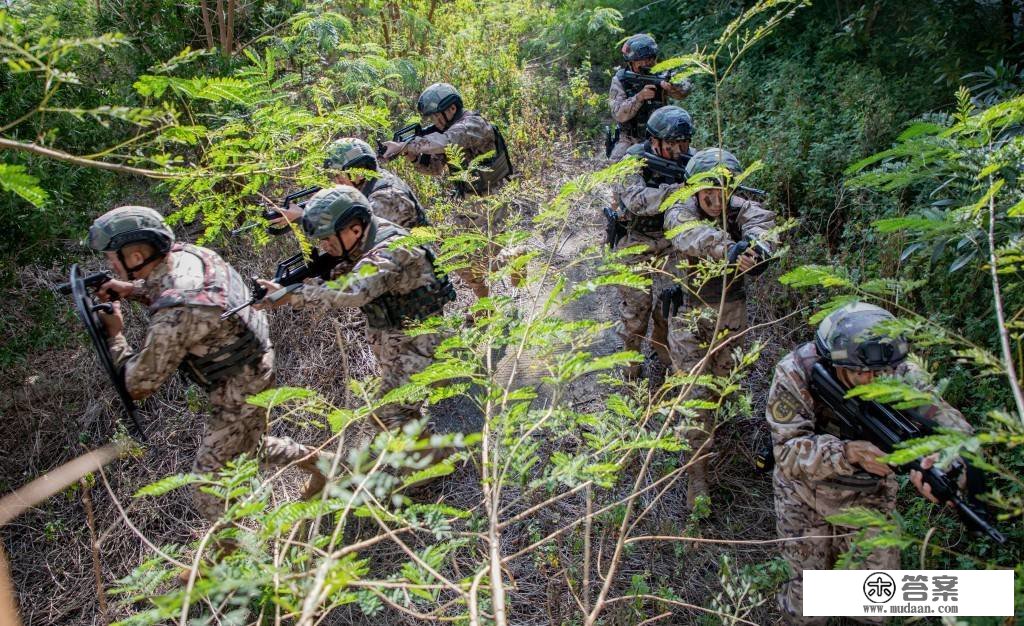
[766,358,855,482]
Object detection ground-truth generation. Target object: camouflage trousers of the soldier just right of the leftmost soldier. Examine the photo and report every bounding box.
[367,328,442,429]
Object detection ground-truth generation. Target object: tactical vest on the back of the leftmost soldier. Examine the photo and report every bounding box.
[150,244,270,390]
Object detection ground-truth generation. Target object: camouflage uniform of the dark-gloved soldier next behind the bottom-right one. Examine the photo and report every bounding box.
[665,195,775,505]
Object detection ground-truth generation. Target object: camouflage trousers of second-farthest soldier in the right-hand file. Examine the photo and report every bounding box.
[615,231,672,365]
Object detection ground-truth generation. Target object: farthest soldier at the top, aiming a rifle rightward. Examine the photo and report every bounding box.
[608,35,693,161]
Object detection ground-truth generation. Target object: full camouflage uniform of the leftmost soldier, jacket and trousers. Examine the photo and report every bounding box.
[109,244,314,519]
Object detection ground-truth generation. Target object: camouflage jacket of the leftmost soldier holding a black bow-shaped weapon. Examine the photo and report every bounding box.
[108,244,272,398]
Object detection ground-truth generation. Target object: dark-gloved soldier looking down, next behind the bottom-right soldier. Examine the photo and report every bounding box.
[665,148,775,508]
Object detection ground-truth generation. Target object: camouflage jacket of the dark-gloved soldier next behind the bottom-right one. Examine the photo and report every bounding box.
[665,195,775,304]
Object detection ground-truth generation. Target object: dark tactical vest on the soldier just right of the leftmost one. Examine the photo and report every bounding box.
[360,223,456,330]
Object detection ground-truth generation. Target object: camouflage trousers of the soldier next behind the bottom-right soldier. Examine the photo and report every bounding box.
[668,299,746,506]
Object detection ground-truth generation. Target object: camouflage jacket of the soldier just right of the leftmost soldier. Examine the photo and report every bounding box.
[291,217,454,328]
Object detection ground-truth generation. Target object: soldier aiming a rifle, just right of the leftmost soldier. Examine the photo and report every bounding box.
[254,185,455,428]
